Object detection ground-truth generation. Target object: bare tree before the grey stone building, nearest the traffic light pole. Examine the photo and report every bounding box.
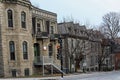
[68,38,84,72]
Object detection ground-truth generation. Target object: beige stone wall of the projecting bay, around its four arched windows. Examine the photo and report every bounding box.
[1,1,33,77]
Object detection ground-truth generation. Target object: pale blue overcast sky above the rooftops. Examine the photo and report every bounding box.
[30,0,120,25]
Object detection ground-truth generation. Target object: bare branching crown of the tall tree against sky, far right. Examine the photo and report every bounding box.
[100,12,120,39]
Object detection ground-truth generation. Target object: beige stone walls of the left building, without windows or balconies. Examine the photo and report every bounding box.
[0,0,59,77]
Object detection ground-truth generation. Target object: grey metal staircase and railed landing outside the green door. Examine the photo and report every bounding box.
[34,56,65,76]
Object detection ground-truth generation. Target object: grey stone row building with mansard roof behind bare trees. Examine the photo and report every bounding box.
[58,22,101,72]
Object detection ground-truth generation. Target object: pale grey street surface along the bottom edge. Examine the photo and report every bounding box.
[0,71,120,80]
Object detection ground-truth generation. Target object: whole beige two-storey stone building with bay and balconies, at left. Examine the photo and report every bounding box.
[0,0,59,77]
